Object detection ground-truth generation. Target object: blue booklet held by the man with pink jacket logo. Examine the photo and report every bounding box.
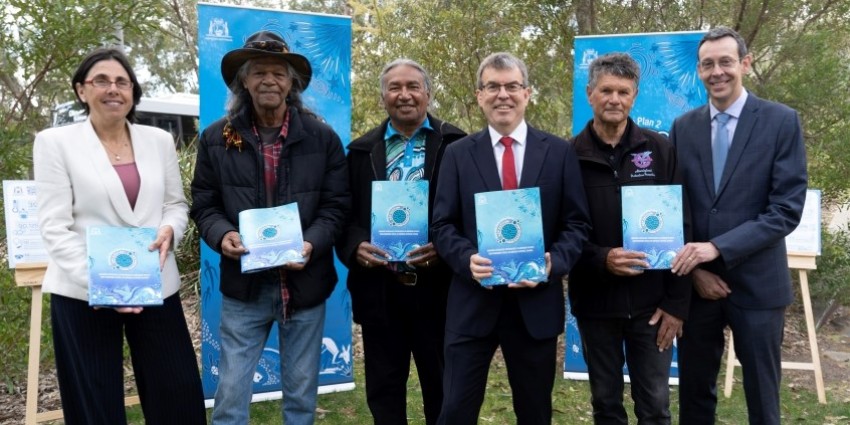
[621,185,685,269]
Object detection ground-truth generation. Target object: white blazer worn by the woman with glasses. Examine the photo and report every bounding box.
[33,120,188,301]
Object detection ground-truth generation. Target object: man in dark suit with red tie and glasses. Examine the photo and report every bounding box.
[432,53,590,425]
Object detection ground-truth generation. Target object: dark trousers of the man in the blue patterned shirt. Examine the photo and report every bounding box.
[361,282,446,425]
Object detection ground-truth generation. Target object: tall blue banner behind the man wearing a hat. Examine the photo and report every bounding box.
[198,3,354,405]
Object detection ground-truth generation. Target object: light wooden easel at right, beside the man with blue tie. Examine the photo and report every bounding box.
[723,253,826,404]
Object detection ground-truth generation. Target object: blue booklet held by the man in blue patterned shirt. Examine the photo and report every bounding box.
[371,180,428,261]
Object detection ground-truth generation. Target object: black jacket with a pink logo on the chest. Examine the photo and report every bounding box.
[569,119,691,319]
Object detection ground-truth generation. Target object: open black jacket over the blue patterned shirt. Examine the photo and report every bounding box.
[337,114,466,323]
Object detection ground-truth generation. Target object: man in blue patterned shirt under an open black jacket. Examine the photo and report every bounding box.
[337,59,466,425]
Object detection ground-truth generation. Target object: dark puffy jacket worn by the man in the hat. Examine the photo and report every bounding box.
[189,107,351,308]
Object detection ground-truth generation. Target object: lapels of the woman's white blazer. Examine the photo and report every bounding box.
[83,120,139,226]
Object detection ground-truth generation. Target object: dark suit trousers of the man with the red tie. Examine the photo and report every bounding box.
[437,288,558,425]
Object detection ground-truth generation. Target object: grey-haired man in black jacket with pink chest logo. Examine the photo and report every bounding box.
[569,53,691,425]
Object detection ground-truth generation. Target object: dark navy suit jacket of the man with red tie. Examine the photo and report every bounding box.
[432,126,590,339]
